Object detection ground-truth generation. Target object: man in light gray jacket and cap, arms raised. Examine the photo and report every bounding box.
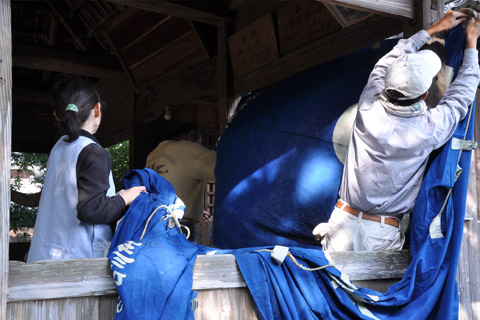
[313,11,480,251]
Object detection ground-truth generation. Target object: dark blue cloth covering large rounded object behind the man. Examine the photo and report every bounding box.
[213,41,396,248]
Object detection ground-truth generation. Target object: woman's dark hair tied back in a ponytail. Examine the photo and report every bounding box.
[50,74,100,142]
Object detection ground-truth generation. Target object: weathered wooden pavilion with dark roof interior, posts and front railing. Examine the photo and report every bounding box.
[0,0,480,319]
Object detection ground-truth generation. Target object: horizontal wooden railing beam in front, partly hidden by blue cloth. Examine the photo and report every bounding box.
[8,249,410,302]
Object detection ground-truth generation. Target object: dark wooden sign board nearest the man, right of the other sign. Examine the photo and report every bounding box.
[278,1,341,55]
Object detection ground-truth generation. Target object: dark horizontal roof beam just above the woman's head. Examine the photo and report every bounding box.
[13,44,126,79]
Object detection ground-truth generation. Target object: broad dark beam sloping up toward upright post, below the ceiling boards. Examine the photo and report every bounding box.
[136,57,218,123]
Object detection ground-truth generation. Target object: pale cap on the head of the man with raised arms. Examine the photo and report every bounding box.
[385,50,442,100]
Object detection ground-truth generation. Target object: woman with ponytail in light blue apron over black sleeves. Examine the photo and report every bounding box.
[27,74,145,262]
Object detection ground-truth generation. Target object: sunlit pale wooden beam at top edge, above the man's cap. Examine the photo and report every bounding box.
[316,0,415,19]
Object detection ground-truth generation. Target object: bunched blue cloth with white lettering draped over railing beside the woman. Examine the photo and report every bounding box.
[108,169,198,320]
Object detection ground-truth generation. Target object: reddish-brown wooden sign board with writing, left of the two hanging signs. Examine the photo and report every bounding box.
[228,13,279,77]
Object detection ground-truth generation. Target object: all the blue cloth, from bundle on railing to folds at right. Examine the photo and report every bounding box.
[109,28,473,320]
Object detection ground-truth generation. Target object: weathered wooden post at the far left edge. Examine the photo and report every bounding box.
[0,0,12,319]
